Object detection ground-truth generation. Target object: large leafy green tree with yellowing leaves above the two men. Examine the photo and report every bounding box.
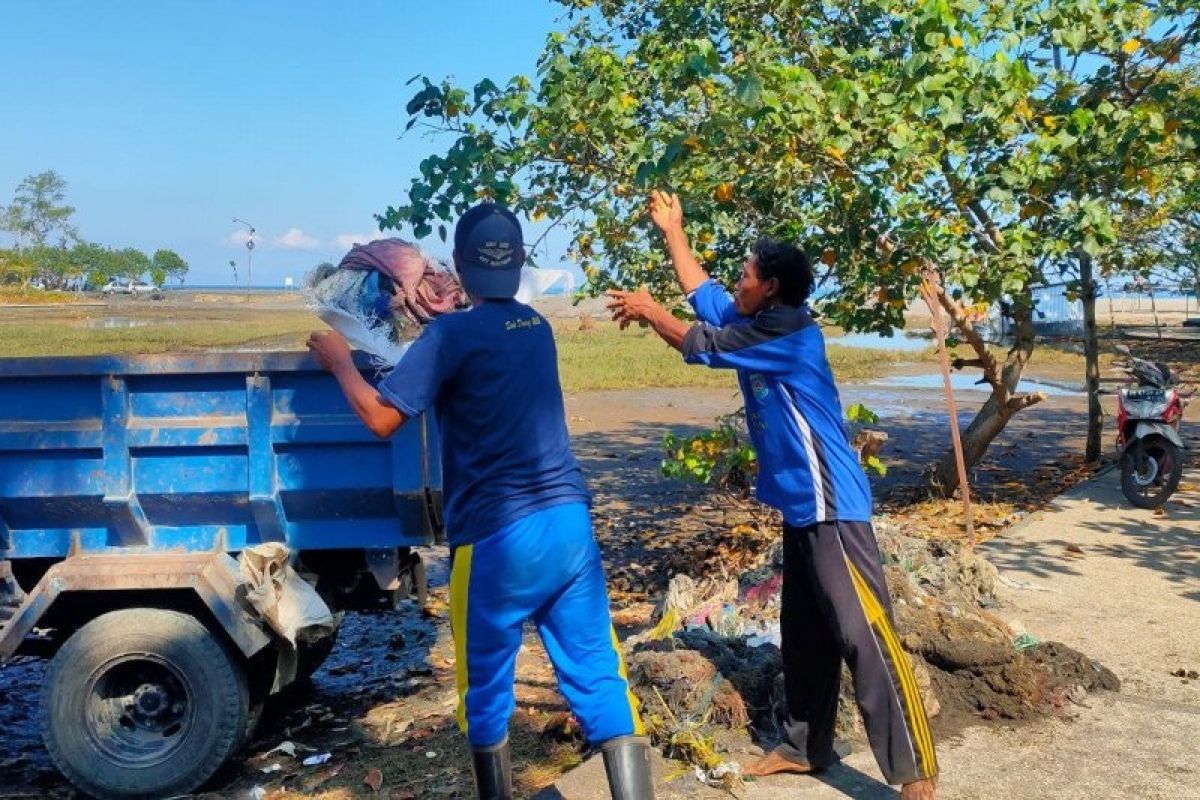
[379,0,1198,491]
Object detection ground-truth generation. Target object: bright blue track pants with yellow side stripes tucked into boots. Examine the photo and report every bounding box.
[450,503,643,747]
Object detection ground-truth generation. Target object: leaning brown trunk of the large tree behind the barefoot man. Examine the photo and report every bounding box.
[930,295,1044,497]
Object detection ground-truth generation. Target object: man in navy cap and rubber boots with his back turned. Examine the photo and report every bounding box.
[308,203,653,800]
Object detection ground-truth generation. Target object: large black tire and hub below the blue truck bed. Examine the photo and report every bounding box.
[42,608,248,800]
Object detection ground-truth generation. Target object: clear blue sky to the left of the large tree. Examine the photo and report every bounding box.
[0,0,563,285]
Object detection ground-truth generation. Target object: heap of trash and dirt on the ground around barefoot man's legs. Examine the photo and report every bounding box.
[626,521,1120,788]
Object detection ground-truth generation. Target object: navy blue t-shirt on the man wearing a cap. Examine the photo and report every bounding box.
[378,300,590,547]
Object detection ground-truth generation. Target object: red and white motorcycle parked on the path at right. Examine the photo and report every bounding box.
[1117,347,1188,509]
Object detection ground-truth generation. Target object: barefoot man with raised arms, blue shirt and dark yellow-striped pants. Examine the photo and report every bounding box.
[608,192,937,800]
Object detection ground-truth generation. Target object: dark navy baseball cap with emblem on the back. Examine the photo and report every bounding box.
[454,203,524,299]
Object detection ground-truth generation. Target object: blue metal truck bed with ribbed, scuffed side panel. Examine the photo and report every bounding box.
[0,353,440,561]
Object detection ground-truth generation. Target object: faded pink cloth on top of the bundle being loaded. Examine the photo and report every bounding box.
[337,239,467,325]
